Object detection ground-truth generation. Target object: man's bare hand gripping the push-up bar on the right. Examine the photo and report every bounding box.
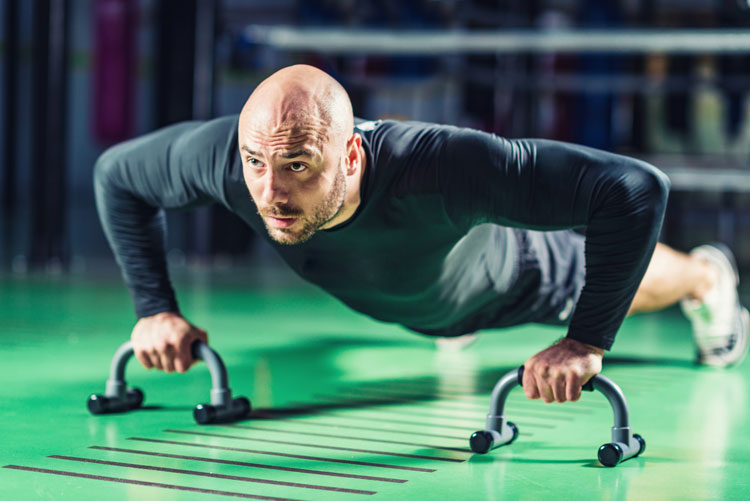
[523,338,604,403]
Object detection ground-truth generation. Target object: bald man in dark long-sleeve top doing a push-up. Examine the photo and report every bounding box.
[95,65,750,402]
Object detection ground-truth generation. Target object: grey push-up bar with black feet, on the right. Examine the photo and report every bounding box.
[469,366,646,467]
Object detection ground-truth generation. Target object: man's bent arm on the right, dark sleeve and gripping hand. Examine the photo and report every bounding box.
[440,129,669,401]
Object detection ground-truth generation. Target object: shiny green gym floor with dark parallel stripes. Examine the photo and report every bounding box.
[0,271,750,501]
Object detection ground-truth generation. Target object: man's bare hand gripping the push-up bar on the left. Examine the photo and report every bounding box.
[130,312,208,372]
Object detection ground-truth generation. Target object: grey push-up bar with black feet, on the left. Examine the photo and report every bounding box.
[88,341,251,424]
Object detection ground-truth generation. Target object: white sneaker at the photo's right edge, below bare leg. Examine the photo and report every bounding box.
[680,244,750,367]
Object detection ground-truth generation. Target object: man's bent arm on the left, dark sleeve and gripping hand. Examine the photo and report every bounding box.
[94,117,236,371]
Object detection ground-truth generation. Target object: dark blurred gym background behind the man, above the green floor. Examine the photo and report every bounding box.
[0,0,750,276]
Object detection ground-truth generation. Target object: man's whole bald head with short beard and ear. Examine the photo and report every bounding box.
[237,65,365,245]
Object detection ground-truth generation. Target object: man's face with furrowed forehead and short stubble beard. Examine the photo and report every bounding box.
[239,123,346,245]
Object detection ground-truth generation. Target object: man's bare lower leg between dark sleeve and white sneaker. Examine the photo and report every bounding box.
[628,243,719,315]
